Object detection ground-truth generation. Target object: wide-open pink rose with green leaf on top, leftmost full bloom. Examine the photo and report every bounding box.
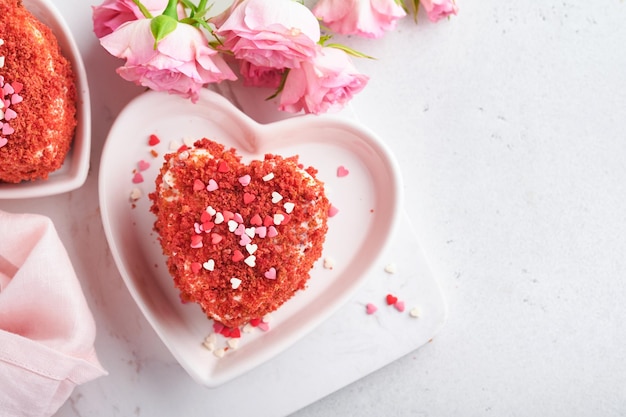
[100,19,236,102]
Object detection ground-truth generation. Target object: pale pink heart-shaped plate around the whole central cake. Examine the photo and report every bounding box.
[99,89,402,387]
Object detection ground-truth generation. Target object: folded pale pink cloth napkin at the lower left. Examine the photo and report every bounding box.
[0,210,106,417]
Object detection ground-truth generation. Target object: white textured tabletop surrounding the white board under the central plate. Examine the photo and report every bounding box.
[0,0,626,417]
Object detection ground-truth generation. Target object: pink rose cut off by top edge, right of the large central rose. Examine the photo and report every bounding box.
[313,0,406,38]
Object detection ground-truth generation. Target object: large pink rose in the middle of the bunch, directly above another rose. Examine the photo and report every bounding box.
[212,0,320,68]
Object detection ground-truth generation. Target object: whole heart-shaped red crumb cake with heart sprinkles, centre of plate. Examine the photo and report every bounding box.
[150,139,330,327]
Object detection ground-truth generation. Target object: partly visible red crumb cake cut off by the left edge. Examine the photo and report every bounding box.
[0,0,76,183]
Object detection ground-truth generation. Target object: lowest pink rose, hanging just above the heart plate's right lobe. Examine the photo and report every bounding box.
[278,48,369,114]
